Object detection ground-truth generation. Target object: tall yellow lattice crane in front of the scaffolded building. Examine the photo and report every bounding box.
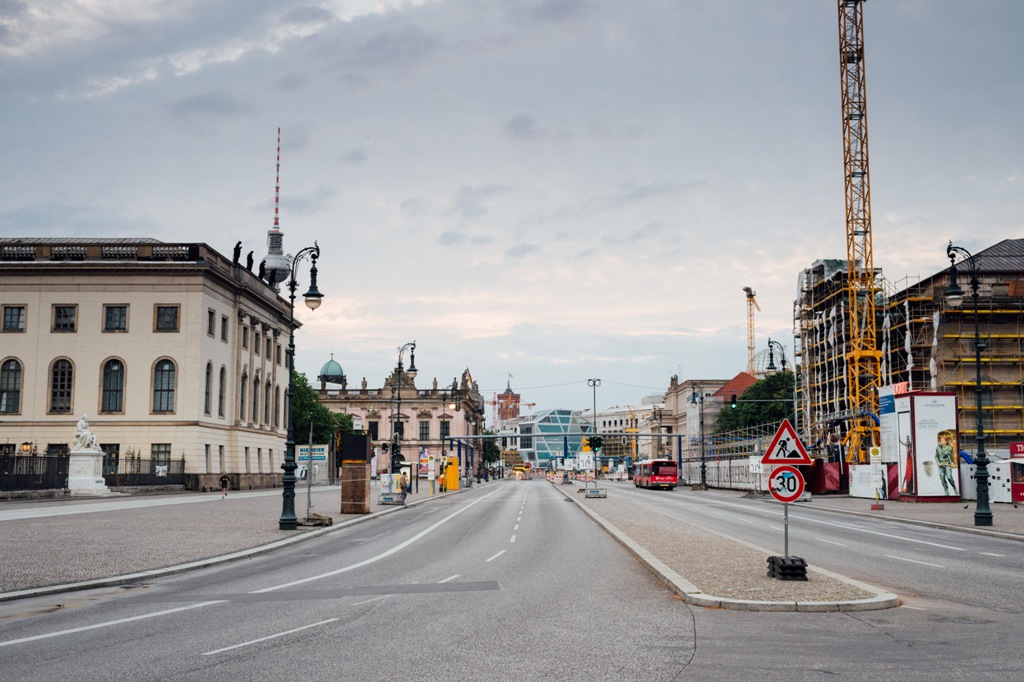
[839,0,882,462]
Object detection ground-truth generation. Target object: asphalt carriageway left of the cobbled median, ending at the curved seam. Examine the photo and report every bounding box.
[0,480,694,680]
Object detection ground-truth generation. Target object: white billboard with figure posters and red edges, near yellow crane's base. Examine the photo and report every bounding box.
[896,393,961,499]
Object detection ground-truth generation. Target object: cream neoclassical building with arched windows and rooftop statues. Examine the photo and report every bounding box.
[0,239,289,485]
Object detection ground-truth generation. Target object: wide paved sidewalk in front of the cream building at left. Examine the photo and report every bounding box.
[0,480,446,601]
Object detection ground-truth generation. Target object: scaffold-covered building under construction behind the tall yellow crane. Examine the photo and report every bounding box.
[794,239,1024,462]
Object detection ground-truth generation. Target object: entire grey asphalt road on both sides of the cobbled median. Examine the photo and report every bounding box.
[0,480,1024,681]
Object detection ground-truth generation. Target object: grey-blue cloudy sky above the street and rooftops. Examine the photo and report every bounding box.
[0,0,1024,409]
